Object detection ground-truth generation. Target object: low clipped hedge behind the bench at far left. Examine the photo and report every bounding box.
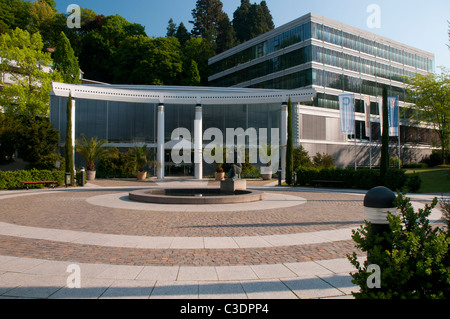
[0,169,65,190]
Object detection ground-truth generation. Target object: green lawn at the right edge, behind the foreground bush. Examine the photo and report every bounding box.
[406,165,450,193]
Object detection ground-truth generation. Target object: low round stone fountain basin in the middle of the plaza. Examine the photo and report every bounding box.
[129,188,266,205]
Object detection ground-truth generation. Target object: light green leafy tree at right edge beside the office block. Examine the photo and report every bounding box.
[407,69,450,164]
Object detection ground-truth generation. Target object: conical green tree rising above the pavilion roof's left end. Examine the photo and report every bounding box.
[53,32,81,84]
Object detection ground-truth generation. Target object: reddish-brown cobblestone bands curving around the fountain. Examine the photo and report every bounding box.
[0,189,363,266]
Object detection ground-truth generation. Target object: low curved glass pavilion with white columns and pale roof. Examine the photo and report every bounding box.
[50,83,315,179]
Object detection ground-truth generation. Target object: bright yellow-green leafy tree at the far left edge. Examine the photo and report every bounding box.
[0,28,61,117]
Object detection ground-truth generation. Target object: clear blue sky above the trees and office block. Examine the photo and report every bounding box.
[56,0,450,72]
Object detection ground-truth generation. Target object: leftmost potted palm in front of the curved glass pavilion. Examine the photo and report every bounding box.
[75,134,108,181]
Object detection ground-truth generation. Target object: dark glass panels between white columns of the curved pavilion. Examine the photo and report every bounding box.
[50,96,281,144]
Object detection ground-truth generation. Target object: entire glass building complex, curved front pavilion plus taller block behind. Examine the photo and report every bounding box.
[50,14,434,178]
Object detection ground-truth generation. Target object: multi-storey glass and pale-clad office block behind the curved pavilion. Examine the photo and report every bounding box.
[209,14,434,166]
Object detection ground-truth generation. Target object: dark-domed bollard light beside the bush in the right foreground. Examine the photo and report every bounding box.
[364,186,397,258]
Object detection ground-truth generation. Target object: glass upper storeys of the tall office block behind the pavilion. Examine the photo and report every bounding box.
[210,16,434,121]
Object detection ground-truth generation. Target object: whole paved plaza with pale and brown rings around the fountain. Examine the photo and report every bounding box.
[0,178,440,299]
